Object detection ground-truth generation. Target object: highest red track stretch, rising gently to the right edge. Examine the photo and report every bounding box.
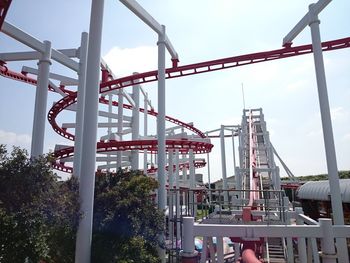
[100,37,350,93]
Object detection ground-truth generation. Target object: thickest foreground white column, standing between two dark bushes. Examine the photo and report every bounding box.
[75,0,104,263]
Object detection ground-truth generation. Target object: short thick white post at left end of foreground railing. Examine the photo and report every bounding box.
[180,217,198,263]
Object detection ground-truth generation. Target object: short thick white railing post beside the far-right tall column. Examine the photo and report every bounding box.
[319,218,337,263]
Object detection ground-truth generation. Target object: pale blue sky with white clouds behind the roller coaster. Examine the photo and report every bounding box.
[0,0,350,184]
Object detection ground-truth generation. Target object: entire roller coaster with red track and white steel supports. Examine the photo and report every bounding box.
[0,0,350,263]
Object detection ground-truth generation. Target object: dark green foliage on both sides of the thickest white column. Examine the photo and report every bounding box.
[0,145,164,263]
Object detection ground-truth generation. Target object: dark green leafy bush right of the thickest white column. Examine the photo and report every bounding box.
[92,170,164,263]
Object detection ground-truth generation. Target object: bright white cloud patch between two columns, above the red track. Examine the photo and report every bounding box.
[103,46,158,77]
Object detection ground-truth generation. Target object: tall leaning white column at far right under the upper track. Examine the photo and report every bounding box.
[309,4,349,263]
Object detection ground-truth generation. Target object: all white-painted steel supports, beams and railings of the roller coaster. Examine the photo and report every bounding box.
[0,0,350,263]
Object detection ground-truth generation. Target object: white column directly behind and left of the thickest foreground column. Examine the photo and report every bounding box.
[73,32,89,178]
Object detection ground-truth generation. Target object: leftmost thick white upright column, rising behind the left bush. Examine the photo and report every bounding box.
[31,41,51,158]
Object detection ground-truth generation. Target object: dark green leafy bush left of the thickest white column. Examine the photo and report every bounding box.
[0,145,79,263]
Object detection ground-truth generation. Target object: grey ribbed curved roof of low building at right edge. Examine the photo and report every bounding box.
[297,179,350,203]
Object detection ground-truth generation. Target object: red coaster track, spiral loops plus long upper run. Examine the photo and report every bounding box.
[0,37,350,174]
